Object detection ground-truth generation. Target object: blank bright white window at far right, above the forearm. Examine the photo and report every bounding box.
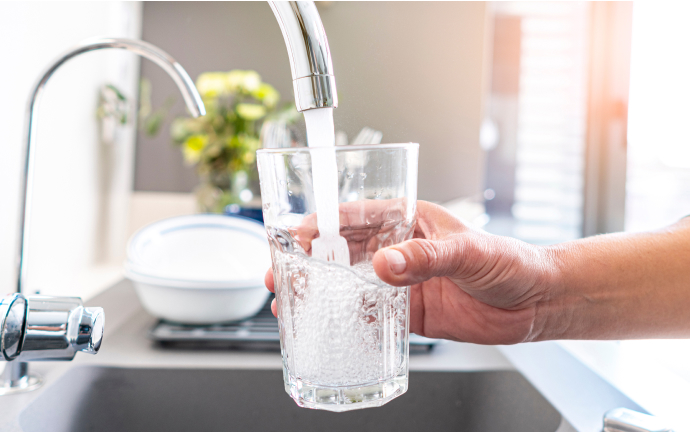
[625,2,690,233]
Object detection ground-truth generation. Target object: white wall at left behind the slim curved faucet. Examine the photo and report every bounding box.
[0,2,141,296]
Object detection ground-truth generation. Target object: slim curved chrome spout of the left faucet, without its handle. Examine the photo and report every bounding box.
[16,38,206,293]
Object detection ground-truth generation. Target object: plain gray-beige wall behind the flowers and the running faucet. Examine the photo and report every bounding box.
[135,2,488,201]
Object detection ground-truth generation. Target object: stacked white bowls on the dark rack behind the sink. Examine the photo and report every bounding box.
[125,215,271,324]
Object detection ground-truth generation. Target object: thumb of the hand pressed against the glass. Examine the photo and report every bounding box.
[373,239,463,286]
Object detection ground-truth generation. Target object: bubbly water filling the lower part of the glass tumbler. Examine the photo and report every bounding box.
[274,252,408,386]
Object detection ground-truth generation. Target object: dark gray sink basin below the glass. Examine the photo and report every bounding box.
[19,366,561,432]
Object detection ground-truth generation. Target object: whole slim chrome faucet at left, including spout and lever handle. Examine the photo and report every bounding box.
[0,39,206,395]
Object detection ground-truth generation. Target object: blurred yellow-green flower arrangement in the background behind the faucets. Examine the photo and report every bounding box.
[170,70,298,213]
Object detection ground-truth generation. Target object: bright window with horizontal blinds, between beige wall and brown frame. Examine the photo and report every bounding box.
[483,2,589,244]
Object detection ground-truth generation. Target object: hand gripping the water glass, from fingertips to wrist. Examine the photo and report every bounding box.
[266,201,555,344]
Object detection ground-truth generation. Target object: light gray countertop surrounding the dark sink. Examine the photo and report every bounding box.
[0,281,641,432]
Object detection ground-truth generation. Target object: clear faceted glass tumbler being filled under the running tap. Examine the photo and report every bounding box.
[257,143,419,411]
